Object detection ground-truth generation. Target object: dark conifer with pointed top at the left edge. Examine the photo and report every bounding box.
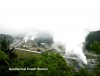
[0,37,18,76]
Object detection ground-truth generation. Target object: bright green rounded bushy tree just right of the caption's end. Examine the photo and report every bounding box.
[40,52,72,76]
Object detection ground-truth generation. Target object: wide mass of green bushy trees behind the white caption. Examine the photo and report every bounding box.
[18,52,73,76]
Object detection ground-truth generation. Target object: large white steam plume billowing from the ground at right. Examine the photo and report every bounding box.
[54,25,100,64]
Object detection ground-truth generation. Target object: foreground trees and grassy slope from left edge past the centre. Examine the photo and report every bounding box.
[0,38,71,76]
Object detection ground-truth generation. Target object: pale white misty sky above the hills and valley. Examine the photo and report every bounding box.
[0,0,100,63]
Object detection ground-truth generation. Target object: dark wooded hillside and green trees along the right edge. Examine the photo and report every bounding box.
[85,31,100,76]
